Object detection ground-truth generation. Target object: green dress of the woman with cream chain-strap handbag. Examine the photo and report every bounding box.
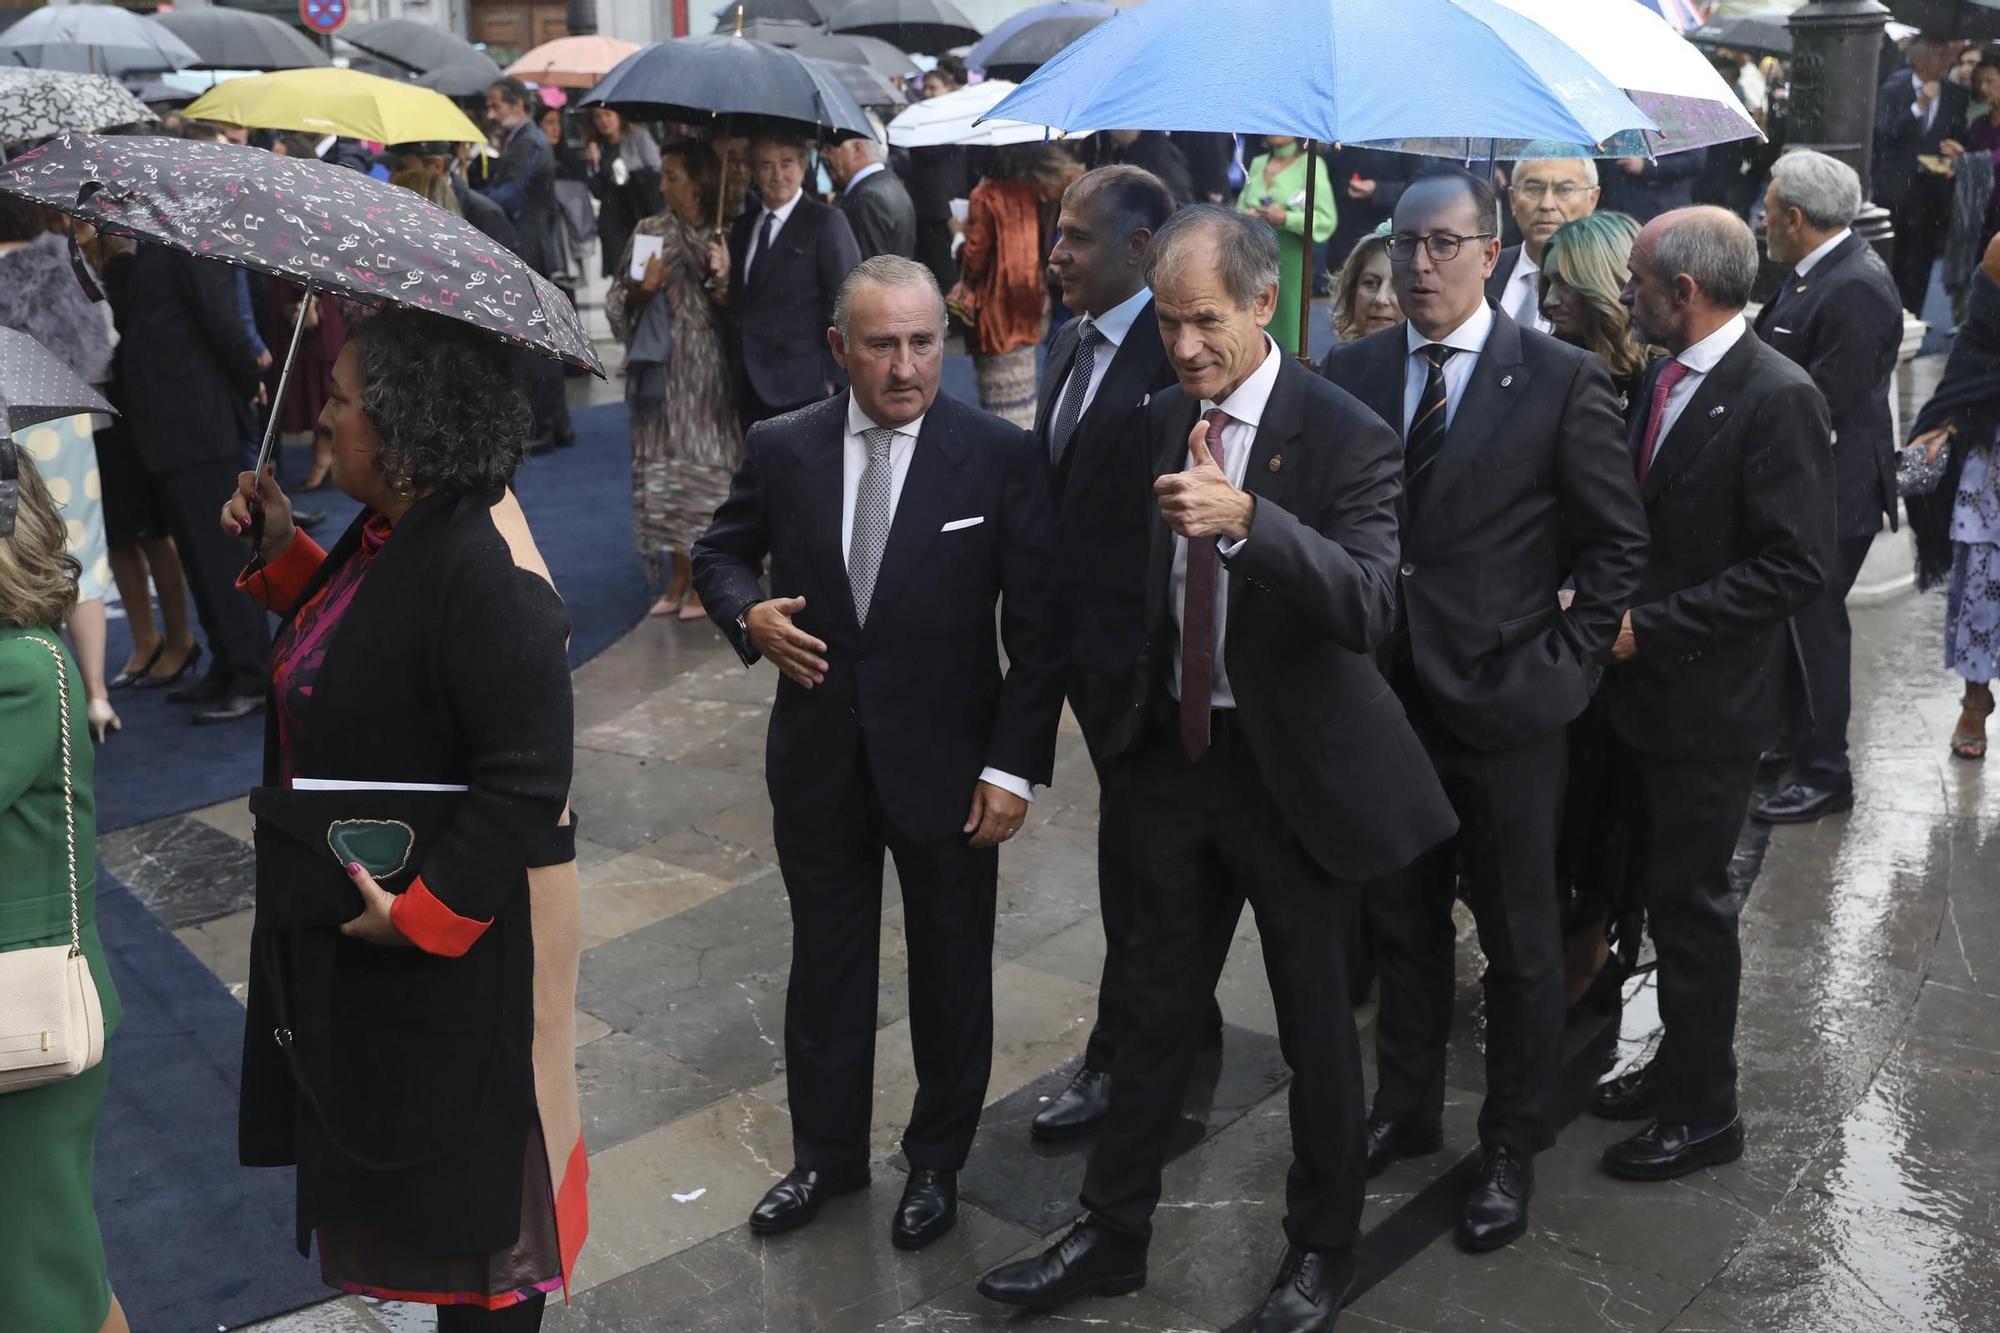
[0,624,120,1333]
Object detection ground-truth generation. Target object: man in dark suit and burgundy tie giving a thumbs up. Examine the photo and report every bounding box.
[980,204,1454,1333]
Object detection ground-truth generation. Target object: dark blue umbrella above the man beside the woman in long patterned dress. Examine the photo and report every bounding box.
[580,36,874,138]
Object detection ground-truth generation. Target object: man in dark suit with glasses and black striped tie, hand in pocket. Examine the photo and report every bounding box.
[1326,172,1646,1249]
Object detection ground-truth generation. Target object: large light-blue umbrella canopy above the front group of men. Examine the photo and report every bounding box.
[994,0,1658,158]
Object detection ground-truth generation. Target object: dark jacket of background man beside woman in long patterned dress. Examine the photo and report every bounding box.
[730,196,862,406]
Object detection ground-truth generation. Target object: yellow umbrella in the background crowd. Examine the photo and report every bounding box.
[182,68,486,144]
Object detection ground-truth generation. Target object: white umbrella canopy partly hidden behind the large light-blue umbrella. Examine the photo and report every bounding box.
[1500,0,1764,156]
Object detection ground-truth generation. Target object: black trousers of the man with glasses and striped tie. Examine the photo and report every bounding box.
[1364,673,1570,1155]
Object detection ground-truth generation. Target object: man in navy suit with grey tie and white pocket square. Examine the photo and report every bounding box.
[694,254,1062,1249]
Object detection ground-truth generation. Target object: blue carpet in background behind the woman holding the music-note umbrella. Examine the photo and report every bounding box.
[98,402,646,833]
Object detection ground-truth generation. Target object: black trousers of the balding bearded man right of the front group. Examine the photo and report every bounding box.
[1616,743,1758,1127]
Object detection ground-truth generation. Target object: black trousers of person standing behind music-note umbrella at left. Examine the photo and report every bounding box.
[152,458,270,695]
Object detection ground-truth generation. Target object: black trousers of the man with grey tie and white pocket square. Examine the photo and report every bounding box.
[776,759,1000,1171]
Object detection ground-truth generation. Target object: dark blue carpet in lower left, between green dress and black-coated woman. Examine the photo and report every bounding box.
[96,867,334,1333]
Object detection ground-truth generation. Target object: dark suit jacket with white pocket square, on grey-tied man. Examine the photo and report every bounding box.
[692,392,1062,841]
